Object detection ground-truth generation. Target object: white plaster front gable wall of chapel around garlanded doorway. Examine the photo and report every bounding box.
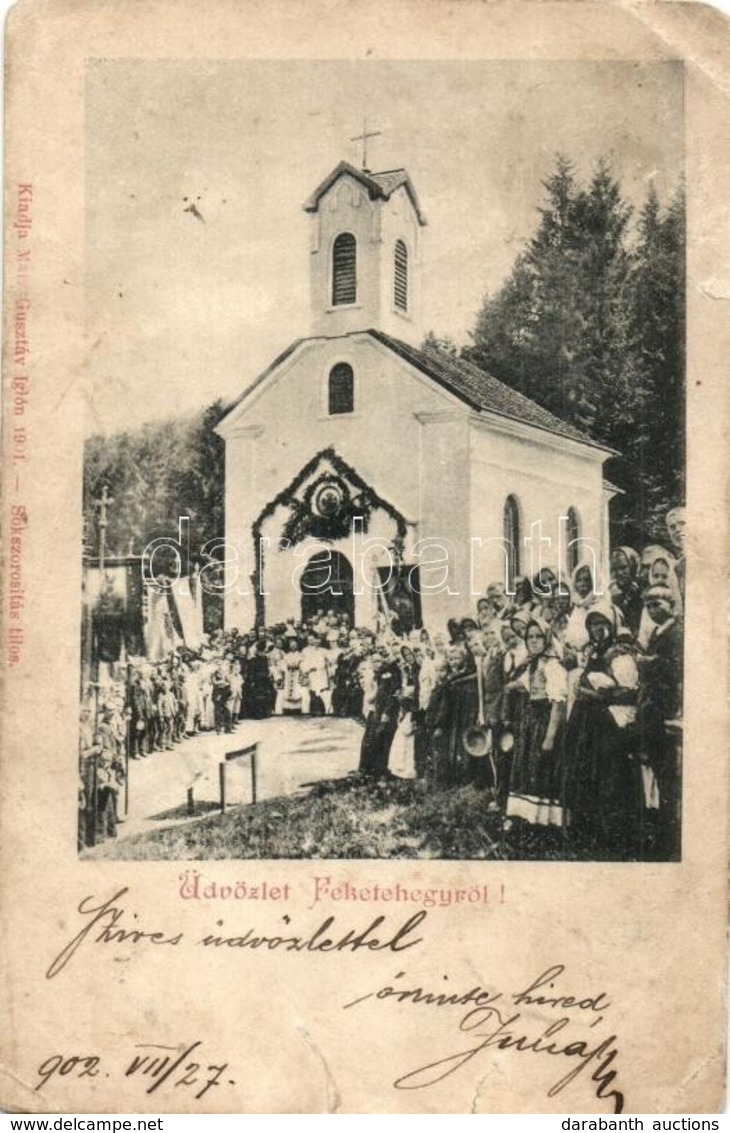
[222,335,468,629]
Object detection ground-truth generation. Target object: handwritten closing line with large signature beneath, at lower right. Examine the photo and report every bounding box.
[343,964,623,1114]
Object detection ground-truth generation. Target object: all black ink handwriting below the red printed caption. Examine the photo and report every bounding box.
[45,888,623,1114]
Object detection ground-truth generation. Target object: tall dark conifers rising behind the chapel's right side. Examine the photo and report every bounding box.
[464,156,684,539]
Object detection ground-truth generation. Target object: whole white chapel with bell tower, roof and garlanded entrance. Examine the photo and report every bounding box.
[217,162,613,630]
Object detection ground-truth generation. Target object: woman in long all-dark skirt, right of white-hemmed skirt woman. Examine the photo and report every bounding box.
[565,602,644,859]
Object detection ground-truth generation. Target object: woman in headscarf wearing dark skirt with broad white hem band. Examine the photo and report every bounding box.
[507,615,567,830]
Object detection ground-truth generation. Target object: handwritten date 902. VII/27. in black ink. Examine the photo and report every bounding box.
[35,1039,236,1100]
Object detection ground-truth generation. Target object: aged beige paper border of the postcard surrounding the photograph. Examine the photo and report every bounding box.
[0,0,730,1113]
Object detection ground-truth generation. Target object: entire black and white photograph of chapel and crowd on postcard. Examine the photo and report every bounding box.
[78,58,686,867]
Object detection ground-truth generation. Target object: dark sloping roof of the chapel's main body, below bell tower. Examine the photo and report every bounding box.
[216,327,613,452]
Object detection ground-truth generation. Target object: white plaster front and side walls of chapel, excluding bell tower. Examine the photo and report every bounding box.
[217,334,605,629]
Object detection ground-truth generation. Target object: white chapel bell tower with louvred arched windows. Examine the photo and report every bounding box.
[304,161,426,346]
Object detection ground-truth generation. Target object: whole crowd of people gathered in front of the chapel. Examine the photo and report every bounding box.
[80,514,684,859]
